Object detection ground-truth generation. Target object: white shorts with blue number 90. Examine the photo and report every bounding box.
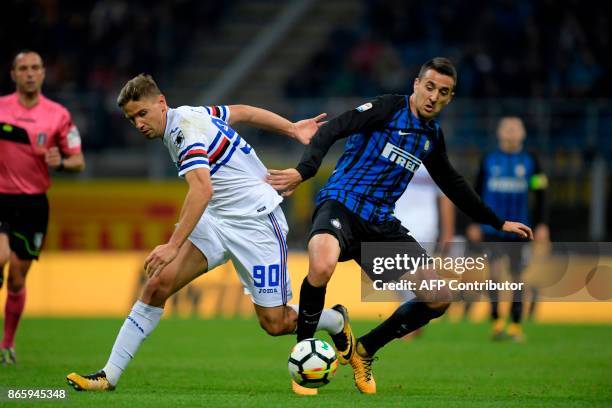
[189,207,292,307]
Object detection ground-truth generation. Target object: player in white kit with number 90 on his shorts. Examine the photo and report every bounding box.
[67,74,352,394]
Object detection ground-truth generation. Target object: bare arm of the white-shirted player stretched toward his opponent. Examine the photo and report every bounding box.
[229,105,327,145]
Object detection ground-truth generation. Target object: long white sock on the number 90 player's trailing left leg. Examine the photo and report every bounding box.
[103,300,164,386]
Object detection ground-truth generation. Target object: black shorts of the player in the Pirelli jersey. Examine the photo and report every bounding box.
[308,200,427,278]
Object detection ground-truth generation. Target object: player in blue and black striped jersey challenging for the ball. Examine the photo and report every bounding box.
[268,58,531,394]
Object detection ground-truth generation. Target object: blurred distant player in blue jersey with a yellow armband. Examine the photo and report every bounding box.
[467,116,549,342]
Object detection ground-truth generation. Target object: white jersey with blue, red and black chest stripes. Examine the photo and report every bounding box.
[164,106,283,217]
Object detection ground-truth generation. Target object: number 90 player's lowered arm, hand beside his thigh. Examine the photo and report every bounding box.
[144,168,213,277]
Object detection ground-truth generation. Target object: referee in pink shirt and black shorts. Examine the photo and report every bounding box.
[0,50,85,364]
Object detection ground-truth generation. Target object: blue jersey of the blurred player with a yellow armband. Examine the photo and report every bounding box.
[476,149,547,239]
